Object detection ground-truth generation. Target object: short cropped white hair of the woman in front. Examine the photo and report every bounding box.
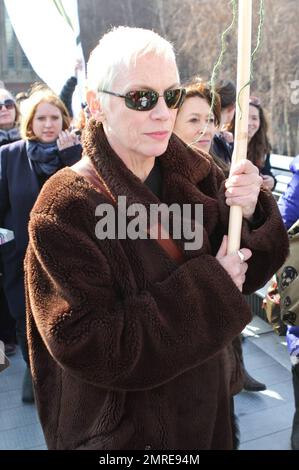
[87,26,176,107]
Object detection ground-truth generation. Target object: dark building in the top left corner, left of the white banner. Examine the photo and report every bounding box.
[0,0,40,93]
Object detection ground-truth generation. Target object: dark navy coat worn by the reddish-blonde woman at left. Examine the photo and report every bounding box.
[0,140,81,317]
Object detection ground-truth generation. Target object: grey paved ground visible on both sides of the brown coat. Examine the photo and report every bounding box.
[0,317,294,450]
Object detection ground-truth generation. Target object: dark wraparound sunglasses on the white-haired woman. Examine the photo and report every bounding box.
[100,88,186,111]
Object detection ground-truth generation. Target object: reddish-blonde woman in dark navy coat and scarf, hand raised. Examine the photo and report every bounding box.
[0,88,81,401]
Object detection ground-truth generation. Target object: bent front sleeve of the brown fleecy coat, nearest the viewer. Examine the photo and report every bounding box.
[25,205,251,390]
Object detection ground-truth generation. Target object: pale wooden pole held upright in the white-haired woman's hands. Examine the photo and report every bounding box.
[227,0,252,254]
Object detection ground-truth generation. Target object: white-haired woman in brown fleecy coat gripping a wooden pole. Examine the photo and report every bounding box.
[26,27,287,450]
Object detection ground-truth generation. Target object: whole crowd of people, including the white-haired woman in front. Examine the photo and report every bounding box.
[0,27,299,450]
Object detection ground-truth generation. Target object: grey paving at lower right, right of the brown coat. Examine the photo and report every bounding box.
[235,317,294,450]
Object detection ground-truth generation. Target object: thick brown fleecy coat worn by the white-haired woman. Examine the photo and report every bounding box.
[26,121,287,450]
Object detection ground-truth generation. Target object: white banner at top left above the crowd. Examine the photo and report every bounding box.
[4,0,85,114]
